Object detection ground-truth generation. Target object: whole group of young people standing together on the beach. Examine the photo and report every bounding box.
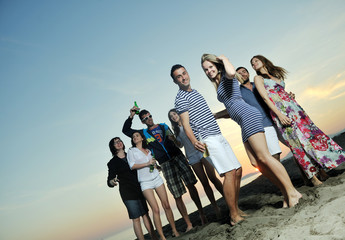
[107,54,345,239]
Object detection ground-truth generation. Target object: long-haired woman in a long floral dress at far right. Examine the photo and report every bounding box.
[250,55,345,186]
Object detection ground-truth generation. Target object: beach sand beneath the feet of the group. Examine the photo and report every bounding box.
[152,133,345,240]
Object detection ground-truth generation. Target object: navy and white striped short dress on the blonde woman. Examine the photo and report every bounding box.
[217,75,264,143]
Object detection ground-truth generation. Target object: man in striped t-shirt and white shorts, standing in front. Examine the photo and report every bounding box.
[170,64,245,225]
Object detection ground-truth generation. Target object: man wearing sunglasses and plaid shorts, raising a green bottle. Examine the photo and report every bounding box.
[122,106,207,232]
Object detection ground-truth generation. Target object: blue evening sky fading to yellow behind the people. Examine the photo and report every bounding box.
[0,0,345,240]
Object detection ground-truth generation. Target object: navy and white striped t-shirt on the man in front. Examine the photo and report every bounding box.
[175,89,221,141]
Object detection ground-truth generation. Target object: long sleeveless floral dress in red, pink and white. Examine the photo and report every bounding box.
[264,79,345,179]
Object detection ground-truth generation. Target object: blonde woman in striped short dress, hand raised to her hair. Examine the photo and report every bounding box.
[201,54,302,207]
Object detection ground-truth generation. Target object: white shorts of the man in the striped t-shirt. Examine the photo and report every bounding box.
[203,135,241,175]
